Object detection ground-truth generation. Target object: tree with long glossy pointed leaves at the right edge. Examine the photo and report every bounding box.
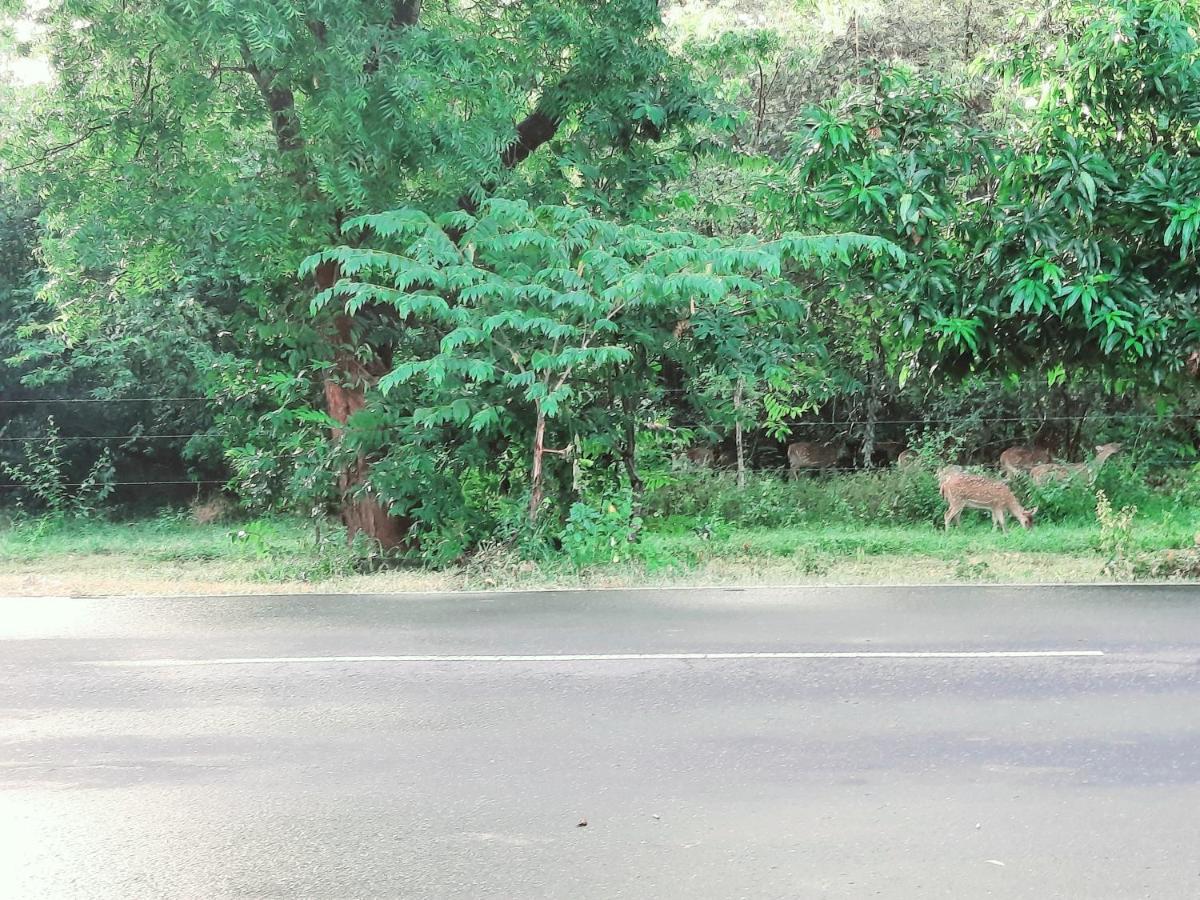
[956,0,1200,382]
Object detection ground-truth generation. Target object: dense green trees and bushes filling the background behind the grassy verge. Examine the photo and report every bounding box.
[0,0,1200,571]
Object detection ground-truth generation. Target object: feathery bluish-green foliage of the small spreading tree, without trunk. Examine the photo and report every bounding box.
[305,199,905,458]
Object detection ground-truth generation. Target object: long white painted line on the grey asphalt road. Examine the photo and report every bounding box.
[91,650,1104,668]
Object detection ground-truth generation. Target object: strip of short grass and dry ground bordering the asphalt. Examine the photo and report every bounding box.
[0,510,1200,595]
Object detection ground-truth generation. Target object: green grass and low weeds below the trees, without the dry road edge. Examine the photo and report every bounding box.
[7,466,1200,587]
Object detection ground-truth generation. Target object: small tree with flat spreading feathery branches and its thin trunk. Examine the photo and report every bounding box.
[304,199,899,549]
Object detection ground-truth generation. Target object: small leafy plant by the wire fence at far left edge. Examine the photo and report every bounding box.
[0,416,116,520]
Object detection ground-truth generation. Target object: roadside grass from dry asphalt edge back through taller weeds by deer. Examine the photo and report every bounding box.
[0,467,1200,594]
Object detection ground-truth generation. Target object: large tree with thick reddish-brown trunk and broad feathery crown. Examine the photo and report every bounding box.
[4,0,703,546]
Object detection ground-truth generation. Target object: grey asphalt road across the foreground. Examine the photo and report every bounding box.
[0,588,1200,900]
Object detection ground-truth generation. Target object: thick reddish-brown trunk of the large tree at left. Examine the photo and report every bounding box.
[316,263,413,550]
